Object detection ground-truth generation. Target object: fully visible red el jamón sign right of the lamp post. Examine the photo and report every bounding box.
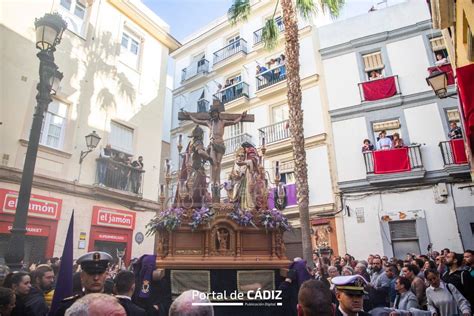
[92,206,135,230]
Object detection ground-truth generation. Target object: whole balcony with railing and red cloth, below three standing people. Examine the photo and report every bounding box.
[362,145,425,183]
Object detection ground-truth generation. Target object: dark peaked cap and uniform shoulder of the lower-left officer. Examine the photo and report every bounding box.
[54,251,113,316]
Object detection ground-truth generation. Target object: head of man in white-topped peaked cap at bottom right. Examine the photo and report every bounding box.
[331,274,370,316]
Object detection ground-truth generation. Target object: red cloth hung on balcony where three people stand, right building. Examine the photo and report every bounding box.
[373,148,411,174]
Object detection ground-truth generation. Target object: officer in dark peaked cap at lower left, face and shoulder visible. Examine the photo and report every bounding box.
[54,251,113,316]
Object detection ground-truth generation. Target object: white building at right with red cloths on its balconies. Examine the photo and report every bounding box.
[319,0,474,258]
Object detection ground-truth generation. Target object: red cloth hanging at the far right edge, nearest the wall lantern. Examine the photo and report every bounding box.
[456,64,474,150]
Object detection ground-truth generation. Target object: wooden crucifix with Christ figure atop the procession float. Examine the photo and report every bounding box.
[178,99,255,202]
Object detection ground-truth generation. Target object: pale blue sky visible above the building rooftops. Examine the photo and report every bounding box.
[142,0,402,41]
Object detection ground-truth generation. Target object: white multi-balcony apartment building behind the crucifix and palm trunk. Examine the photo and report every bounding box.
[171,0,338,257]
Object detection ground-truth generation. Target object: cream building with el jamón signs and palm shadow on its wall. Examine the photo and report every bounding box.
[0,0,180,263]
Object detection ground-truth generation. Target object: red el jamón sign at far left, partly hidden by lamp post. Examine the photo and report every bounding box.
[0,189,62,220]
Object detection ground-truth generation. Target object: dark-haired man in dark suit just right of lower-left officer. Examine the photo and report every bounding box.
[114,271,146,316]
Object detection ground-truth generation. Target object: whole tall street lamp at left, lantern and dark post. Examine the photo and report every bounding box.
[5,13,67,270]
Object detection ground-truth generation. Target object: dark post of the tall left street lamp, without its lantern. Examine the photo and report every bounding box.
[5,51,57,270]
